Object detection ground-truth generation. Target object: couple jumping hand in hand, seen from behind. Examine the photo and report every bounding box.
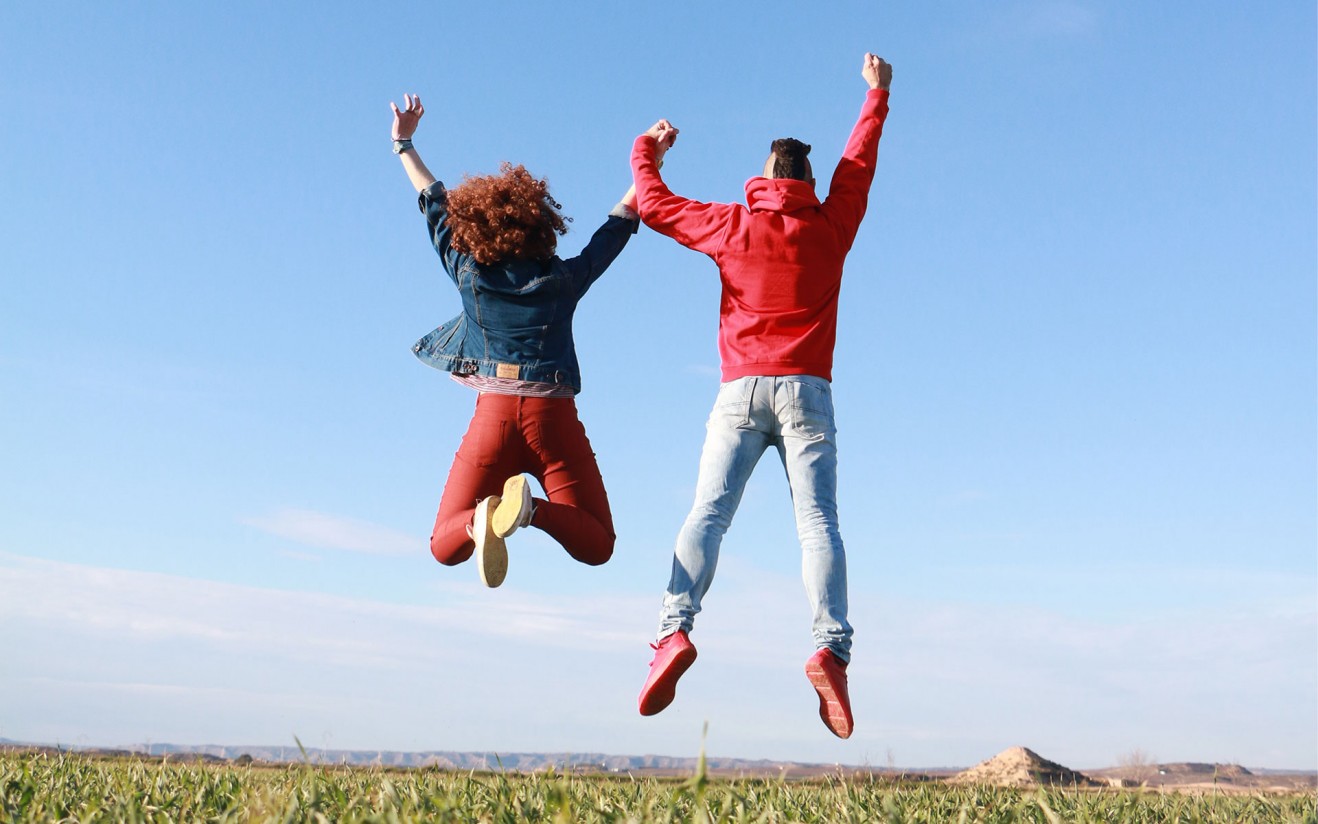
[390,54,892,738]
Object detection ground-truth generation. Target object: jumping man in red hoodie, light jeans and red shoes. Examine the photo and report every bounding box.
[631,54,892,738]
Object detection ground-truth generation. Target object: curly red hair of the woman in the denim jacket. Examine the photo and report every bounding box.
[448,161,569,265]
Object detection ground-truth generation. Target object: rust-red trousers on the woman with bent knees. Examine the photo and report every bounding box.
[430,393,614,564]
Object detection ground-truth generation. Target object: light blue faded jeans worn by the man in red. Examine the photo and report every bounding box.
[659,374,851,661]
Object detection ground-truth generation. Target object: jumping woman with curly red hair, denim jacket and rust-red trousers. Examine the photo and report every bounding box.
[389,95,651,587]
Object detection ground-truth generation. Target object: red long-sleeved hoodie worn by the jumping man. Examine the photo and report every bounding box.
[631,90,888,381]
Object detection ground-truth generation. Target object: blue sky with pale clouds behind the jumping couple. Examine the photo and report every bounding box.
[0,1,1318,769]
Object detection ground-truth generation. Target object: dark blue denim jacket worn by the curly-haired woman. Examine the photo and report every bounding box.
[413,181,639,392]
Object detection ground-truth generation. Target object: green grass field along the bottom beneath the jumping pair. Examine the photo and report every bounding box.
[0,753,1315,824]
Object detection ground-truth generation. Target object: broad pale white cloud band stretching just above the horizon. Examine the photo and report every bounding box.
[0,554,1318,767]
